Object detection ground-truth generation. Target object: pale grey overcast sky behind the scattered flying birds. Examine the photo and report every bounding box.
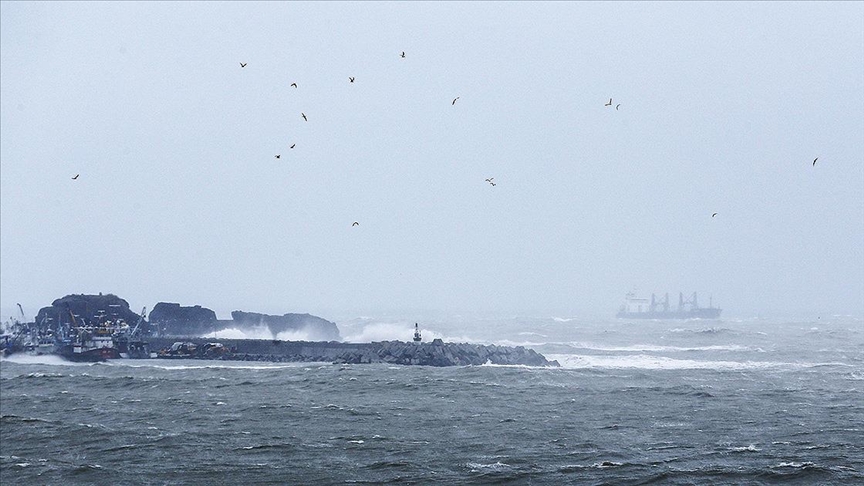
[0,2,864,319]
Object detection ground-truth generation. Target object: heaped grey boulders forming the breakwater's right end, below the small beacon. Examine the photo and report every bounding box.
[335,339,560,366]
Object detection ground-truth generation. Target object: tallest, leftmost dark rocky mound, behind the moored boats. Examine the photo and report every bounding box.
[36,294,141,327]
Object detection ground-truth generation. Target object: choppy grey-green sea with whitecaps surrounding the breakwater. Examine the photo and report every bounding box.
[0,316,864,484]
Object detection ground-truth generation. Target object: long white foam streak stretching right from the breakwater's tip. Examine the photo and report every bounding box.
[545,354,848,370]
